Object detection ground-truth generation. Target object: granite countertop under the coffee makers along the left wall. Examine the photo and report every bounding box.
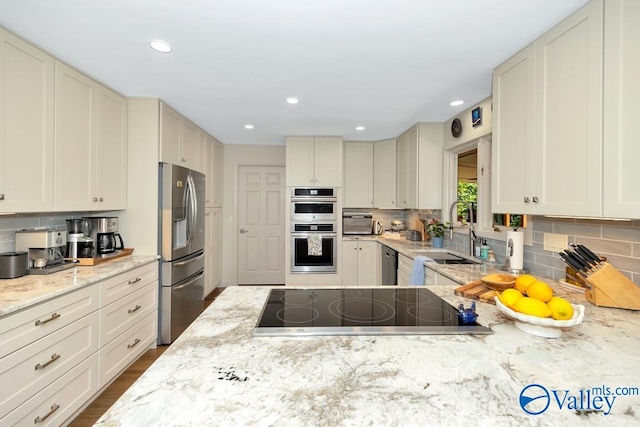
[0,255,158,318]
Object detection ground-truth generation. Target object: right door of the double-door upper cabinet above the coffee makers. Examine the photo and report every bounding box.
[94,85,127,210]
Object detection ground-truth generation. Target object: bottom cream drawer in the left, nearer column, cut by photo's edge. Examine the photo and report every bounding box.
[0,353,98,426]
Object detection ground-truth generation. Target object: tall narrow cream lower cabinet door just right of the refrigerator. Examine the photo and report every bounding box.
[204,208,222,297]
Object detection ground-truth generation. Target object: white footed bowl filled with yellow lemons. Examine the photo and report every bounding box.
[494,275,584,338]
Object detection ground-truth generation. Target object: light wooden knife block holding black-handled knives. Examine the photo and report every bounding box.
[585,262,640,310]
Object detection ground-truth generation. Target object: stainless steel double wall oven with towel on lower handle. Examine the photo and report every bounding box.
[291,188,339,273]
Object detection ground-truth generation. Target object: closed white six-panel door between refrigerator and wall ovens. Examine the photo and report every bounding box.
[238,166,285,284]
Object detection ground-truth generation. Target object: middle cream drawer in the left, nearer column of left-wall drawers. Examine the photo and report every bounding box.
[0,312,98,416]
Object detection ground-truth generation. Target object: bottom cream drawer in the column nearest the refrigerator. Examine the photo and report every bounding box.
[98,311,158,388]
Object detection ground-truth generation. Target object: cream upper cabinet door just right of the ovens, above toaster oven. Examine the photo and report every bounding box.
[343,142,373,208]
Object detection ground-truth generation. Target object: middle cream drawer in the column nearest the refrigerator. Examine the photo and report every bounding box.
[100,281,159,347]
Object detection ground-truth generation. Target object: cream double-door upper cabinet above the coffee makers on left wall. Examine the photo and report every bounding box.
[54,61,127,211]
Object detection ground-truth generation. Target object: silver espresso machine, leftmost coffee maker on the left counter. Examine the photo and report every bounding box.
[16,229,75,274]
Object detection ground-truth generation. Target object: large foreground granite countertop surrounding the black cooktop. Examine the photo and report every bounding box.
[97,286,640,426]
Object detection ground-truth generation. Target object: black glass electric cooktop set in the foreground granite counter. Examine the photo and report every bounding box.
[253,287,493,336]
